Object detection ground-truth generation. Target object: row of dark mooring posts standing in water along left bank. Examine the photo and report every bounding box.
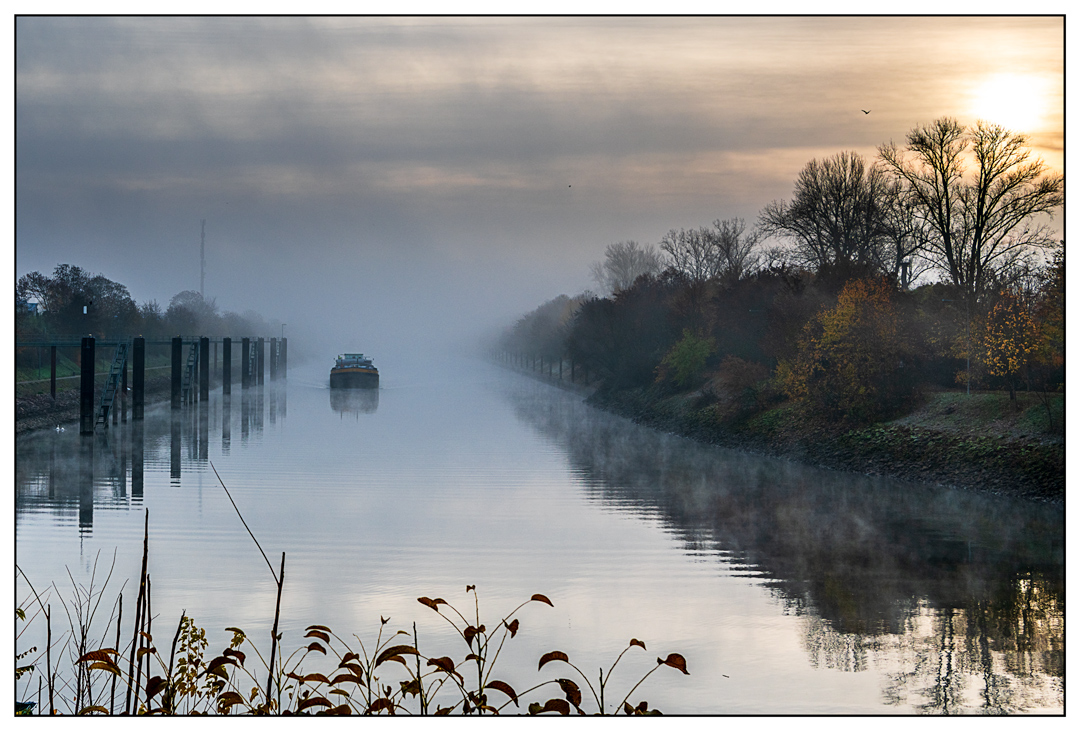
[76,336,288,434]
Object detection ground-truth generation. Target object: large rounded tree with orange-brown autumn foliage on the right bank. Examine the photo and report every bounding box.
[777,277,917,422]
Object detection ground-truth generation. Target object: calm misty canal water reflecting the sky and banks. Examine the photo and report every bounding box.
[15,360,1065,714]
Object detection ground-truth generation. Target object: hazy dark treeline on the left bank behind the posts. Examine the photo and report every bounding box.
[15,263,273,339]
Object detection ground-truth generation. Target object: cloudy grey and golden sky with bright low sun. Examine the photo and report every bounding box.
[13,16,1065,356]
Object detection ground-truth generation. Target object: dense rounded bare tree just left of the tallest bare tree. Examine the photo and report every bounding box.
[759,152,889,270]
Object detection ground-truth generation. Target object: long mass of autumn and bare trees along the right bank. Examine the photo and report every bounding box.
[500,118,1065,421]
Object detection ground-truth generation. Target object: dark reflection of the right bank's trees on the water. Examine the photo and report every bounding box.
[512,387,1065,714]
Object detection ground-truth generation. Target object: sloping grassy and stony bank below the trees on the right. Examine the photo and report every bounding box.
[588,390,1065,504]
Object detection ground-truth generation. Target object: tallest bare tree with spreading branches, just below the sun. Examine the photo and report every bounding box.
[878,117,1065,298]
